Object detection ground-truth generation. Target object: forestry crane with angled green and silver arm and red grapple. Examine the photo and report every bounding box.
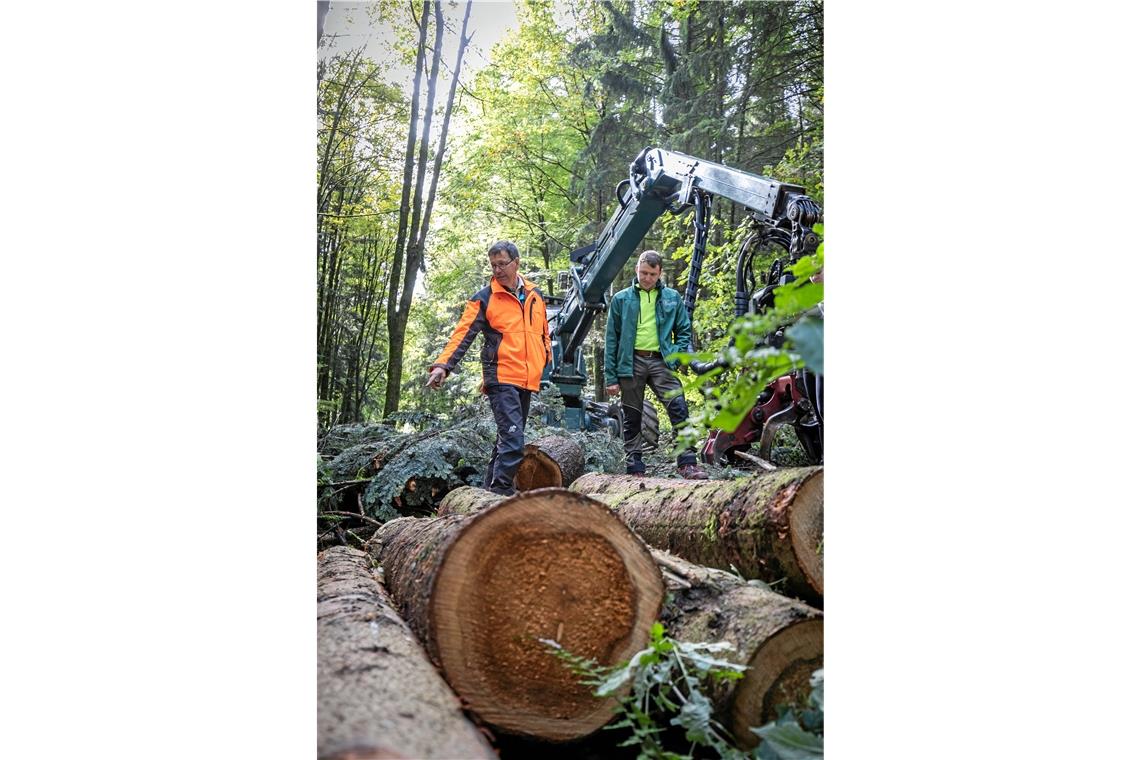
[544,148,823,463]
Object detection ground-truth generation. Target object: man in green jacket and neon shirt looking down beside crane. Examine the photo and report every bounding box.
[605,251,708,480]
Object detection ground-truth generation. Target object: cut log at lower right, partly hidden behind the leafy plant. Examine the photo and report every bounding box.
[652,549,823,749]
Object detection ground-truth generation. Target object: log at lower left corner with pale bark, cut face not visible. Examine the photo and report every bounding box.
[317,547,497,760]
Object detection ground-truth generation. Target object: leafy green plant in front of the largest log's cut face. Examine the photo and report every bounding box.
[540,622,746,760]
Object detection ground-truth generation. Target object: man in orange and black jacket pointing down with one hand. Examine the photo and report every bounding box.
[428,240,551,496]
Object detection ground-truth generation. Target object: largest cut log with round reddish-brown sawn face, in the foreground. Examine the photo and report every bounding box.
[367,489,665,742]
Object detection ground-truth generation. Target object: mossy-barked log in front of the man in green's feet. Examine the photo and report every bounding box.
[571,467,823,603]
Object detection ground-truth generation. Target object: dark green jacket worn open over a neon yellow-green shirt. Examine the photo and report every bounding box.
[605,277,692,385]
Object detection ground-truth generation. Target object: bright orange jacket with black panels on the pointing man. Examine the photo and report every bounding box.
[432,278,552,391]
